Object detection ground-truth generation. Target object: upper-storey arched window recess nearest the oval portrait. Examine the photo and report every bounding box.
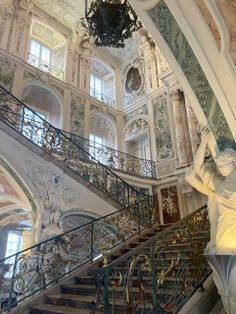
[90,59,115,107]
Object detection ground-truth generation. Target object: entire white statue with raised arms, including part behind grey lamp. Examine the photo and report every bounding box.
[186,126,236,314]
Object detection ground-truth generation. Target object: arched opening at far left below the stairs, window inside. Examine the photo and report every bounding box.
[0,157,37,262]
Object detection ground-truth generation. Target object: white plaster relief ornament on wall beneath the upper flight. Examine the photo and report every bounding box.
[25,160,81,241]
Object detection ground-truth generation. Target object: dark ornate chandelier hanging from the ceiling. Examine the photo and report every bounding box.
[81,0,142,48]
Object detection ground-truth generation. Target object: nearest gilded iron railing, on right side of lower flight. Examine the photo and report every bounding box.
[90,206,211,314]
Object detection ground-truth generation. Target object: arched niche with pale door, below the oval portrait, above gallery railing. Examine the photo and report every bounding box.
[124,115,151,160]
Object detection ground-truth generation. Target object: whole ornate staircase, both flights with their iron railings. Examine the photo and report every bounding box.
[0,87,214,314]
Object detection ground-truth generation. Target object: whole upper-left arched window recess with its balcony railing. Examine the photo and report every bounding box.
[28,20,66,80]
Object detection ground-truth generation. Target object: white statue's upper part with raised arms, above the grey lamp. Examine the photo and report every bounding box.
[186,126,236,254]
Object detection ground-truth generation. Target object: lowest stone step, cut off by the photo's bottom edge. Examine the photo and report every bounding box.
[30,304,103,314]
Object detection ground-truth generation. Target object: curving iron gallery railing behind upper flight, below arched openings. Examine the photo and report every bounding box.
[63,131,156,179]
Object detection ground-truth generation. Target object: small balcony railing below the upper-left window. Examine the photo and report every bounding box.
[28,52,64,80]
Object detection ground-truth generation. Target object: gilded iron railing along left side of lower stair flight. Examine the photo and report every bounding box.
[0,198,156,312]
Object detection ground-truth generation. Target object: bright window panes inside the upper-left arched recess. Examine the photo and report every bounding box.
[29,39,52,66]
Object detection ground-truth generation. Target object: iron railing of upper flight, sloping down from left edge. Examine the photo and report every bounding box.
[0,86,147,207]
